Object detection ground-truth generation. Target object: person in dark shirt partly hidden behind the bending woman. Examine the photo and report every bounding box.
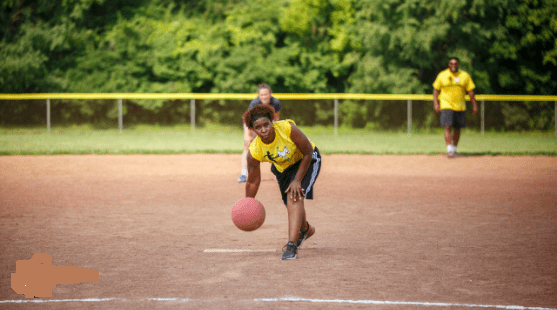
[238,83,282,183]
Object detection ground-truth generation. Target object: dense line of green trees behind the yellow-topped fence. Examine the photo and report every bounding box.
[0,0,557,130]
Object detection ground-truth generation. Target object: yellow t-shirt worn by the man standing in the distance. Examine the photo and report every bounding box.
[433,69,476,111]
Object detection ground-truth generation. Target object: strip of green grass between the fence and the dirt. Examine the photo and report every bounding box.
[0,125,557,156]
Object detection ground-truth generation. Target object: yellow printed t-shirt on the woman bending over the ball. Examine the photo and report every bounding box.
[249,119,315,173]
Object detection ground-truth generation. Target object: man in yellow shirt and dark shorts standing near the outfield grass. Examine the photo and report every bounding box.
[433,57,478,158]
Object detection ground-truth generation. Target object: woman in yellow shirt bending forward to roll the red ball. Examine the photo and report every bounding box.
[244,104,321,260]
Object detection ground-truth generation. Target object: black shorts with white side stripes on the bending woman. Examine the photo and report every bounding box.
[271,147,321,205]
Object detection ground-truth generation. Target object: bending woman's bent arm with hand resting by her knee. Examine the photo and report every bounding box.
[285,123,313,201]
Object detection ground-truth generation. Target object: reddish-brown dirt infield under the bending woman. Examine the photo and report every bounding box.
[0,155,557,309]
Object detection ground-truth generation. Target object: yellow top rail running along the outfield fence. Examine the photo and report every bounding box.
[0,93,557,101]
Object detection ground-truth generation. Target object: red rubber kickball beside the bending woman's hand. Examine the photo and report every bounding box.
[232,197,265,231]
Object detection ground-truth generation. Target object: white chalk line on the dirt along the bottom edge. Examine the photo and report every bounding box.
[0,296,557,310]
